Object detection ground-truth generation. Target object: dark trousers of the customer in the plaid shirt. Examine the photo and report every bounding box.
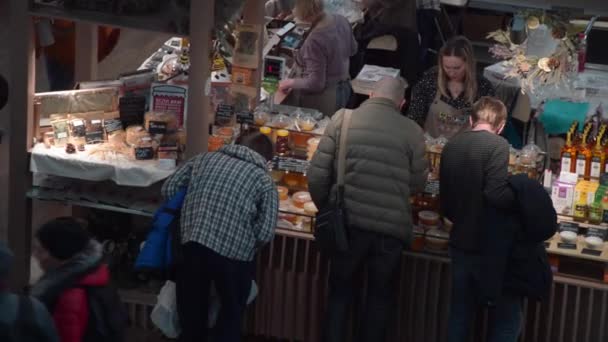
[176,242,253,342]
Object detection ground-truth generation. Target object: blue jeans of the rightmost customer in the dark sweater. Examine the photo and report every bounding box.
[448,248,522,342]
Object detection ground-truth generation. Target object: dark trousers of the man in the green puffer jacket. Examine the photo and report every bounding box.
[324,229,403,342]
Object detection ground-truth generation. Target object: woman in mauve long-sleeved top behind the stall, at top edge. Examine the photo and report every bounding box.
[279,0,357,116]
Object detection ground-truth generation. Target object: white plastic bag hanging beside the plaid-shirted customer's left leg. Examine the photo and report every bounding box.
[150,280,181,339]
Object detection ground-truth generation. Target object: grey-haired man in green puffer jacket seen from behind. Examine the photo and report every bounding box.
[308,78,428,341]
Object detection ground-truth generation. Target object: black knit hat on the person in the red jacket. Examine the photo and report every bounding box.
[36,217,91,260]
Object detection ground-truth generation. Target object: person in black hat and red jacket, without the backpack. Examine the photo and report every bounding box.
[31,217,115,342]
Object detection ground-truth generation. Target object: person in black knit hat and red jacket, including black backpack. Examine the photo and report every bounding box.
[31,217,128,342]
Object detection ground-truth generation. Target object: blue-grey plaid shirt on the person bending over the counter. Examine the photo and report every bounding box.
[162,145,279,261]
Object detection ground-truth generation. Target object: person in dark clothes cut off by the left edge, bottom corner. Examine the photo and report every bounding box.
[0,241,59,342]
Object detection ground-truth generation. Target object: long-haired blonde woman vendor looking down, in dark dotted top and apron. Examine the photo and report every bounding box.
[408,36,495,139]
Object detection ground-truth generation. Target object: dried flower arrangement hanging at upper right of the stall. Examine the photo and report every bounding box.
[487,11,581,92]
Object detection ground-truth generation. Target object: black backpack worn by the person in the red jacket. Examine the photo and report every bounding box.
[82,286,129,342]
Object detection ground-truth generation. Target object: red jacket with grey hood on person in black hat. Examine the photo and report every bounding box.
[31,240,110,342]
